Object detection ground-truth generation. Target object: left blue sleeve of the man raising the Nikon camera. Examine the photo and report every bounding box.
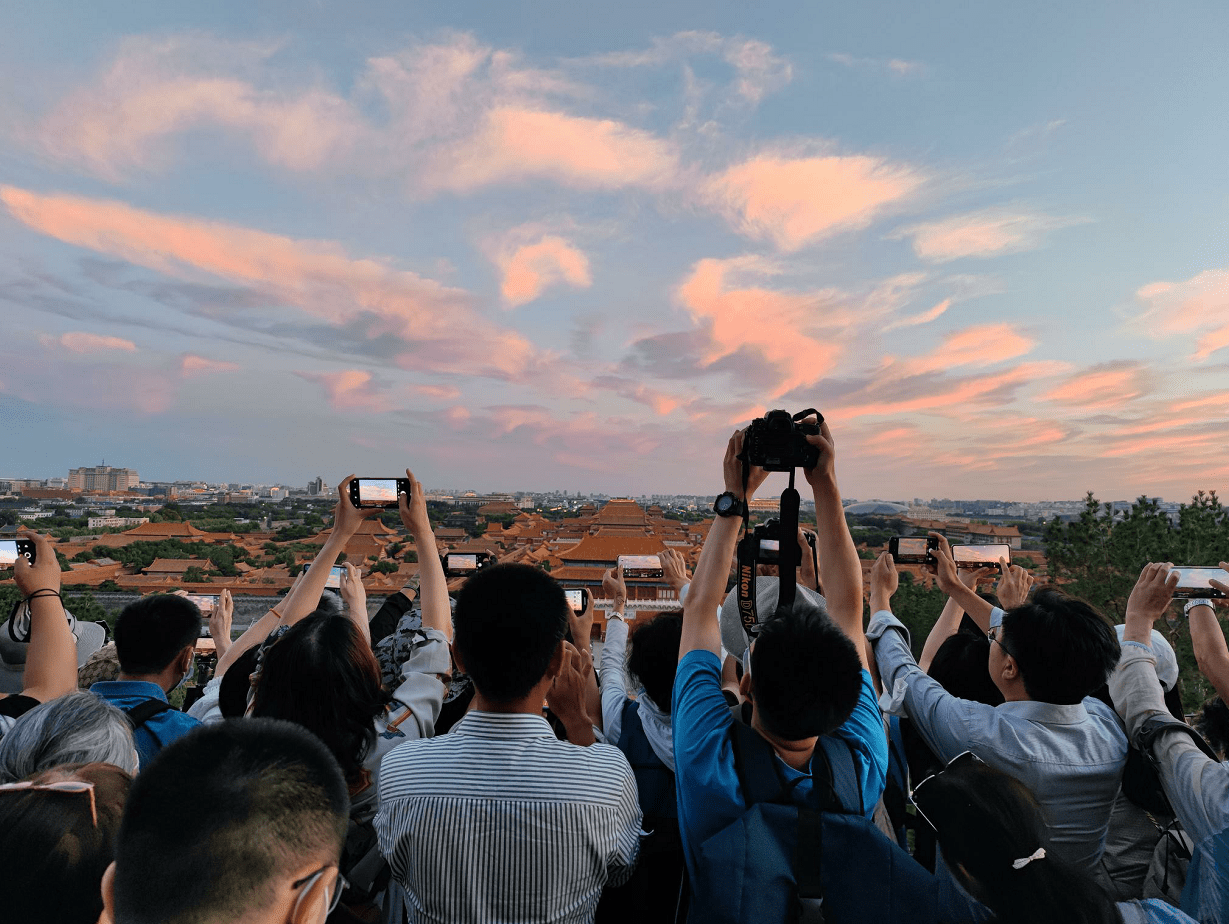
[670,649,746,844]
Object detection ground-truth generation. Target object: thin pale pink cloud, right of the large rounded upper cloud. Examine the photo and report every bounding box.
[890,209,1086,263]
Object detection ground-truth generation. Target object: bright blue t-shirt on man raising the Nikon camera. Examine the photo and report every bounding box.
[670,650,887,881]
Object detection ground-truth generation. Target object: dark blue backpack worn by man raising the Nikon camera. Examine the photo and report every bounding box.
[689,722,940,924]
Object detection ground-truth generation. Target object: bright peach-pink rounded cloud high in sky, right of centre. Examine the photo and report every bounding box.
[703,154,922,252]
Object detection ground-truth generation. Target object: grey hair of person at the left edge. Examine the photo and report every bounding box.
[0,692,136,783]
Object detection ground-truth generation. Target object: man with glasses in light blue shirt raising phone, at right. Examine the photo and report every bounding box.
[866,547,1127,876]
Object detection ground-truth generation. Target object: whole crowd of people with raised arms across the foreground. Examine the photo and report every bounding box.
[0,421,1229,924]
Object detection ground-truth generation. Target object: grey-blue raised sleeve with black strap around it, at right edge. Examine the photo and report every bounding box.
[1110,644,1229,844]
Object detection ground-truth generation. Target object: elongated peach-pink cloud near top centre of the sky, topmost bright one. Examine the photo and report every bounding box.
[423,106,677,193]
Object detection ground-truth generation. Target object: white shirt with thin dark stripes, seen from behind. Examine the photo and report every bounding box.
[375,711,640,924]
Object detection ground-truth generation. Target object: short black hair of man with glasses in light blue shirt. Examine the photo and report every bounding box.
[1002,587,1122,705]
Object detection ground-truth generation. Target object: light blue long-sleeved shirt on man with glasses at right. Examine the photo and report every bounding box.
[866,609,1127,875]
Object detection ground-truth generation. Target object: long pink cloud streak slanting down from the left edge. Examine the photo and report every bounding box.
[0,187,546,378]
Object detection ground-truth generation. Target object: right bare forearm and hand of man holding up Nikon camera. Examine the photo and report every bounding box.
[801,423,869,667]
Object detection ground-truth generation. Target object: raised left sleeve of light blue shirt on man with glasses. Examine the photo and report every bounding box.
[866,609,994,763]
